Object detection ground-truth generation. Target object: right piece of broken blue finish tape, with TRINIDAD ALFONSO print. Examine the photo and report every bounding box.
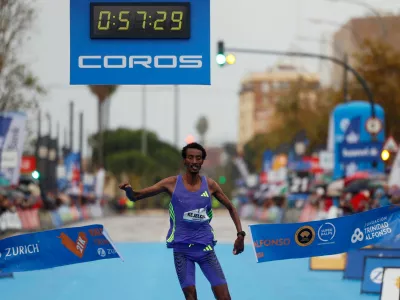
[249,206,400,263]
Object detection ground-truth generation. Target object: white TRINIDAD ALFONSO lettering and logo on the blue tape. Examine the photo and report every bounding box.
[351,217,392,244]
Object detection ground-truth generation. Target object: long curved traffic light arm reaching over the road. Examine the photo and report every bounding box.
[223,42,375,118]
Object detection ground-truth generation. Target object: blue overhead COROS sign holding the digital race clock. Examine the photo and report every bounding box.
[70,0,211,85]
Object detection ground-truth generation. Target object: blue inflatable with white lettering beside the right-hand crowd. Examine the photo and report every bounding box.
[328,101,385,178]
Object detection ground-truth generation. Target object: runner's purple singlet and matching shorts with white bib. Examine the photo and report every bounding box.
[167,175,226,288]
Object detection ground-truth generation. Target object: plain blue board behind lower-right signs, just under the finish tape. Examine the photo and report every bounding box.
[343,248,400,280]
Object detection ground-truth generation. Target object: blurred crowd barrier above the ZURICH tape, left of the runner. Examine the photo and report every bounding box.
[0,204,103,234]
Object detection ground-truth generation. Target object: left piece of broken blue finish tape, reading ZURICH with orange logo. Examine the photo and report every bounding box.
[0,224,122,272]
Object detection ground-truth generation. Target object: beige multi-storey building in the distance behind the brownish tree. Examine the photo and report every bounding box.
[237,64,320,153]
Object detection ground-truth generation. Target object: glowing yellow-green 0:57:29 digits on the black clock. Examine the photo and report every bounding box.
[97,10,183,31]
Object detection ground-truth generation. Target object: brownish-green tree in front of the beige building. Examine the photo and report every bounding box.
[244,84,343,172]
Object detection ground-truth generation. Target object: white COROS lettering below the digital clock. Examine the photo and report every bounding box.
[78,55,203,69]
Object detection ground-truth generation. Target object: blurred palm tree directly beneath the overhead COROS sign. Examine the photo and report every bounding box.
[89,85,118,166]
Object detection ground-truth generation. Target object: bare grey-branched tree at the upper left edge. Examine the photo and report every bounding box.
[0,0,45,111]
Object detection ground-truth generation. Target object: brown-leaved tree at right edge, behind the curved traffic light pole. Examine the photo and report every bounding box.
[349,39,400,141]
